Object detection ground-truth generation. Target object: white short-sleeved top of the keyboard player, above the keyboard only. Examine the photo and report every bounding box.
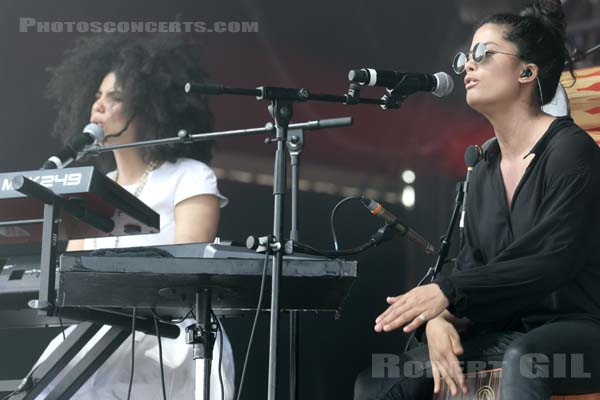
[83,158,229,250]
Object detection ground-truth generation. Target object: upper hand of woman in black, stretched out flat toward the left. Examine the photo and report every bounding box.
[375,283,450,333]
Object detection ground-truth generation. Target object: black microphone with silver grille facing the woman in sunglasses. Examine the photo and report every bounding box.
[348,68,454,97]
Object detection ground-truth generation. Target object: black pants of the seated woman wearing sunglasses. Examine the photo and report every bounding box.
[354,320,600,400]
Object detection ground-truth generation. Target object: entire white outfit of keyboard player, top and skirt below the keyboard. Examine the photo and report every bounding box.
[31,159,235,400]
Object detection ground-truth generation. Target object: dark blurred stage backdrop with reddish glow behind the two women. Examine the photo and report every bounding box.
[0,0,600,399]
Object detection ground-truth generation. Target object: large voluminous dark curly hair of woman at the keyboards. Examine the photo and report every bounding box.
[47,33,213,163]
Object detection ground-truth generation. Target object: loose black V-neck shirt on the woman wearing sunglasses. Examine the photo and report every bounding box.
[435,117,600,329]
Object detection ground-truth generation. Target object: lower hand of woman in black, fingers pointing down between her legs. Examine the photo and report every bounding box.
[425,313,469,396]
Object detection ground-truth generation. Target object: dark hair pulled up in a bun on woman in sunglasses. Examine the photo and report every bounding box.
[478,0,575,106]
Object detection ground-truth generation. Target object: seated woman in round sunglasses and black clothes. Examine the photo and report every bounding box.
[355,0,600,400]
